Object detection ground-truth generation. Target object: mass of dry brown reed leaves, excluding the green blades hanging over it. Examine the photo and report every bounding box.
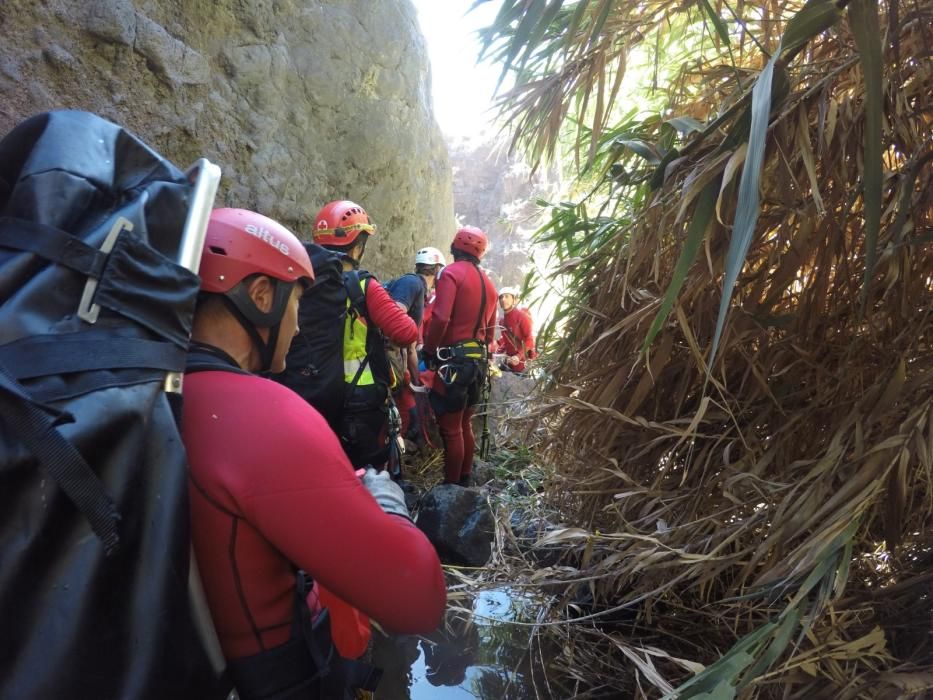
[474,0,933,698]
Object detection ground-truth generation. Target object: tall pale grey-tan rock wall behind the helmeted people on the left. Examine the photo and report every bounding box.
[0,0,454,278]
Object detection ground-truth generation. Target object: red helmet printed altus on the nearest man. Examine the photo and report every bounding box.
[198,209,314,294]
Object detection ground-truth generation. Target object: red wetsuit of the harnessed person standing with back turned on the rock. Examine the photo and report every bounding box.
[424,260,498,483]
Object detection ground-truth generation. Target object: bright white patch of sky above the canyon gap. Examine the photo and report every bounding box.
[412,0,500,137]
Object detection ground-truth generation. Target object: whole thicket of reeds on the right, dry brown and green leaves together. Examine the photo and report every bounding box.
[470,0,933,698]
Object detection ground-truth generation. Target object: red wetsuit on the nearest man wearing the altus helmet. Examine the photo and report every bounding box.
[182,371,446,659]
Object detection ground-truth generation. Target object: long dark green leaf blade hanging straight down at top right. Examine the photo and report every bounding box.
[849,0,884,313]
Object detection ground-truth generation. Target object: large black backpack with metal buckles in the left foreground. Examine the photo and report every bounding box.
[0,111,225,700]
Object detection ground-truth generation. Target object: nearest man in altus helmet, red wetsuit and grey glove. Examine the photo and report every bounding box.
[182,209,446,700]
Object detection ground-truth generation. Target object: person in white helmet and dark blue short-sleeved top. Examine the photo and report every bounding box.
[385,246,447,436]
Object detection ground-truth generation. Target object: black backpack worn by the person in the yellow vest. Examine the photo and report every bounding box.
[274,243,390,435]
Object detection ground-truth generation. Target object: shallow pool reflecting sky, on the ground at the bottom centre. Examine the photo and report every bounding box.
[373,589,541,700]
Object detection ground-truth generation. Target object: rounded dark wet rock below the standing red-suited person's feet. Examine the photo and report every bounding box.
[415,484,494,566]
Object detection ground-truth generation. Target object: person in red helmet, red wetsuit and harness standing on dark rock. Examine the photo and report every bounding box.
[424,226,498,486]
